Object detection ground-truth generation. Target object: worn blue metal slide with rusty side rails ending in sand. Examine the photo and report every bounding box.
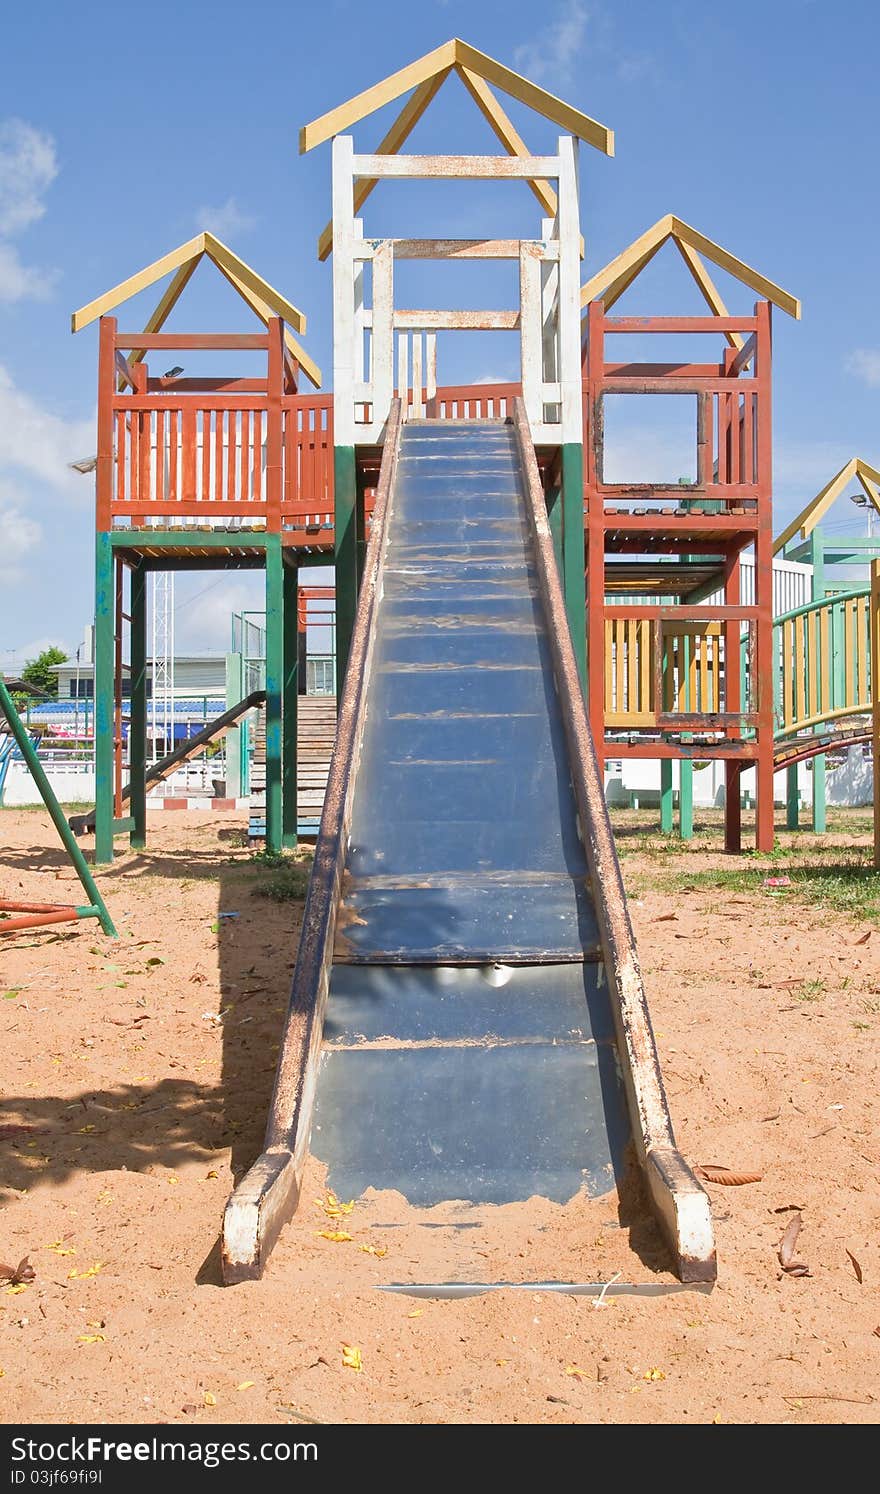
[223,408,714,1280]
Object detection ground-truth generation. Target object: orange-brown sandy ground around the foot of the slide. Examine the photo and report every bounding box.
[0,811,880,1424]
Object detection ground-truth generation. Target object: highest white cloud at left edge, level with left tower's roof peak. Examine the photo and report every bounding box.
[0,120,58,302]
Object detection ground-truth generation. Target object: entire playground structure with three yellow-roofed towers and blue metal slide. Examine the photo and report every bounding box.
[51,40,877,1280]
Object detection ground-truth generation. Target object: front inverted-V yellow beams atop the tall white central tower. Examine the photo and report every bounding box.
[299,37,614,155]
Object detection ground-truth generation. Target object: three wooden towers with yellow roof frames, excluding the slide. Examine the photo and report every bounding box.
[73,40,799,861]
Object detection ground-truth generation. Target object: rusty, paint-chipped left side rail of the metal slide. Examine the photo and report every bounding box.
[221,399,402,1285]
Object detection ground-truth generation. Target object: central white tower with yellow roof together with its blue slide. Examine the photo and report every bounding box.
[223,43,720,1282]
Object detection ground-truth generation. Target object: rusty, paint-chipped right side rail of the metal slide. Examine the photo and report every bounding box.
[514,399,717,1282]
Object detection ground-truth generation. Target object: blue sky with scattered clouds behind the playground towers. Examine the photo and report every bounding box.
[0,0,880,666]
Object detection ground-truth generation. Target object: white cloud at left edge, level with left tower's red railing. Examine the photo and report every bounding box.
[0,363,96,498]
